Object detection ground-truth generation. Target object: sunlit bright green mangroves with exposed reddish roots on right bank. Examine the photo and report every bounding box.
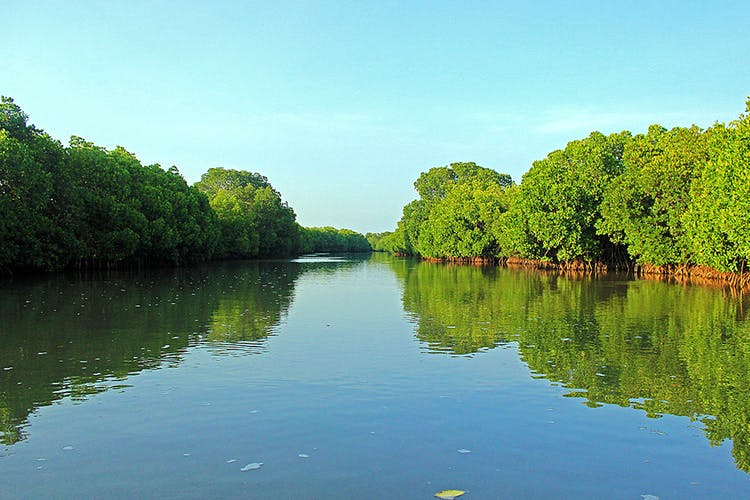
[376,100,750,284]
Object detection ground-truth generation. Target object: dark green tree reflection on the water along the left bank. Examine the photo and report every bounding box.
[0,258,376,445]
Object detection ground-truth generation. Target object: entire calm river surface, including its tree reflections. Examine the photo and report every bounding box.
[0,256,750,499]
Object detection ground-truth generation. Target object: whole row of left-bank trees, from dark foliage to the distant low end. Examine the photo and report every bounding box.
[0,97,370,274]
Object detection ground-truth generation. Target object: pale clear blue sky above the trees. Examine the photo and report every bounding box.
[0,0,750,232]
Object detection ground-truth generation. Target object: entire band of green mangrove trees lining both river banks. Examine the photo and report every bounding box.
[0,97,750,289]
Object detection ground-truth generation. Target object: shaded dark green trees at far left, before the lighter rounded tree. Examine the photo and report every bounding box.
[0,97,218,269]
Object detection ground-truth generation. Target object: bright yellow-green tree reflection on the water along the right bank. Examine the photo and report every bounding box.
[391,260,750,472]
